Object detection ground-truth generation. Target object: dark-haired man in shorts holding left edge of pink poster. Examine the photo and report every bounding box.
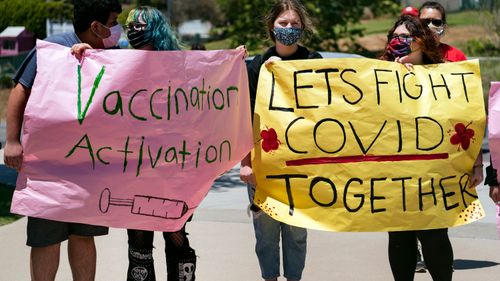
[4,0,122,281]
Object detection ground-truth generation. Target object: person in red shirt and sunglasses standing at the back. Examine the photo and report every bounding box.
[418,1,467,62]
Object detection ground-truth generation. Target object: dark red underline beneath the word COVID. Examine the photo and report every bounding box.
[286,153,449,166]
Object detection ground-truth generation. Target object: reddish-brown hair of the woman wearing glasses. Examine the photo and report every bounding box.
[380,15,444,64]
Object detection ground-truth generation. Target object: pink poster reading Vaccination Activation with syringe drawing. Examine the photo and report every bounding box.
[11,41,252,231]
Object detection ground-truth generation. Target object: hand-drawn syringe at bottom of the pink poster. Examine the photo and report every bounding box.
[99,188,189,219]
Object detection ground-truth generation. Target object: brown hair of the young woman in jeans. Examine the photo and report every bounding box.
[265,0,313,42]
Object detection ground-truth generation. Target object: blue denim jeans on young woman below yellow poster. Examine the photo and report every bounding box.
[247,185,307,280]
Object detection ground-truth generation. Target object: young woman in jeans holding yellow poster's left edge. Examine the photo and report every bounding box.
[240,0,321,281]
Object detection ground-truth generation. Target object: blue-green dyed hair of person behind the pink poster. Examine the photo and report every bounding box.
[127,6,181,51]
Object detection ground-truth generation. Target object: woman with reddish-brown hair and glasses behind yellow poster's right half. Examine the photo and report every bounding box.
[381,15,482,281]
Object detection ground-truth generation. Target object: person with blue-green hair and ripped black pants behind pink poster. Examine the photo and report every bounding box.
[72,6,196,281]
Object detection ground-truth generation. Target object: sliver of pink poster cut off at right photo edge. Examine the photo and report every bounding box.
[488,82,500,182]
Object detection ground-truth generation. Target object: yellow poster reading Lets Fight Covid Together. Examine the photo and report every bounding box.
[252,59,485,231]
